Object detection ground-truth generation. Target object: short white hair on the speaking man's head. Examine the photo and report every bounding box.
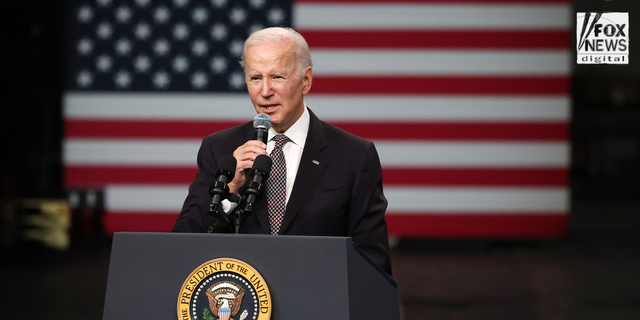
[240,27,313,77]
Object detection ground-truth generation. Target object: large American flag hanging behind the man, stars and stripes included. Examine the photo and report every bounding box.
[63,0,572,237]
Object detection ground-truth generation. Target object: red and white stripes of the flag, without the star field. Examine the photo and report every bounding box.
[64,0,571,237]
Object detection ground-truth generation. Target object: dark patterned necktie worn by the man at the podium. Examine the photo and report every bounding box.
[266,134,291,235]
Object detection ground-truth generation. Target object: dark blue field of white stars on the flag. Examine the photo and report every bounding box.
[65,0,291,92]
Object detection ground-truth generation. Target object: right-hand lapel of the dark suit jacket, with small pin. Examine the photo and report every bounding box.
[278,109,329,234]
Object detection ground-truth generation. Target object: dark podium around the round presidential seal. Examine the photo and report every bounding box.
[103,232,400,320]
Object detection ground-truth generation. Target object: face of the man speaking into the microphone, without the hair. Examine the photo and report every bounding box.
[245,40,312,133]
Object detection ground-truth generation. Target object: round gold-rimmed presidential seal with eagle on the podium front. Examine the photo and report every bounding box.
[178,258,271,320]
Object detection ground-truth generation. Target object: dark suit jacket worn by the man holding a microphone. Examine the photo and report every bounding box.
[173,110,391,274]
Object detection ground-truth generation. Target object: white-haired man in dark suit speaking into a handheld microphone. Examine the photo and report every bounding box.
[173,28,391,274]
